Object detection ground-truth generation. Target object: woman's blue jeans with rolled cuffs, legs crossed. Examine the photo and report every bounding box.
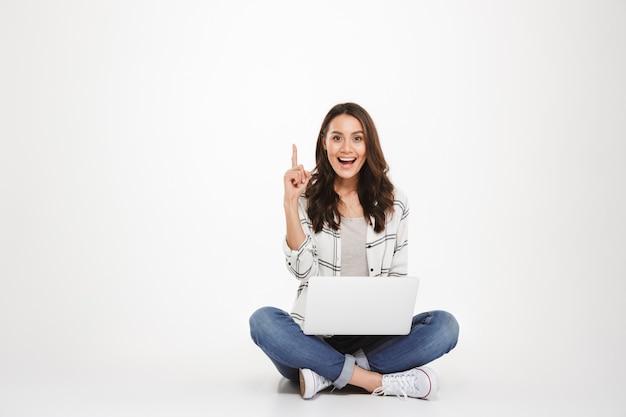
[250,307,459,388]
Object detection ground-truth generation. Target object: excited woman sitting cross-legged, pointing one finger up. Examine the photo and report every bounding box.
[250,103,459,399]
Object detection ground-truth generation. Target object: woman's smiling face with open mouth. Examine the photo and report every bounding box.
[324,114,366,184]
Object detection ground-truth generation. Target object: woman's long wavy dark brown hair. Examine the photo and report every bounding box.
[305,103,394,233]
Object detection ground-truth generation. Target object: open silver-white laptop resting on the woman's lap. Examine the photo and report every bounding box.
[302,276,419,336]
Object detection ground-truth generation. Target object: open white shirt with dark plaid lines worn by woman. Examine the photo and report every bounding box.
[283,189,409,324]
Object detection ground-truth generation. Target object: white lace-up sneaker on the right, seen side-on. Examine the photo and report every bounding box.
[372,366,439,400]
